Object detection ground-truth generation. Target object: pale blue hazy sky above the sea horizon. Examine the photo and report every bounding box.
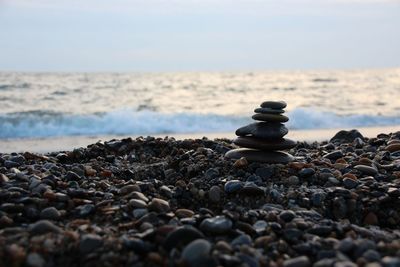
[0,0,400,71]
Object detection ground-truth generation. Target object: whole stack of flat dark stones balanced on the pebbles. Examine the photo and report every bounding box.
[225,101,296,164]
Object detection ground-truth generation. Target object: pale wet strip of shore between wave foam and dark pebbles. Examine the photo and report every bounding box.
[0,125,400,153]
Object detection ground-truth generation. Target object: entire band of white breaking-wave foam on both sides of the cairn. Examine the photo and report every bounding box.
[0,108,400,138]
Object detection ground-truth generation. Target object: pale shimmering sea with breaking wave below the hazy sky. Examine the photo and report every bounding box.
[0,68,400,139]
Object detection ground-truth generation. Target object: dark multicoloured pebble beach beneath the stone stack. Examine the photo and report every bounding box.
[0,131,400,267]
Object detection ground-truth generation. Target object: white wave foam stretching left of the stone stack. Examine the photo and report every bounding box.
[0,109,246,138]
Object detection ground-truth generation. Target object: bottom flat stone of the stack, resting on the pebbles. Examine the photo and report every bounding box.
[225,148,294,164]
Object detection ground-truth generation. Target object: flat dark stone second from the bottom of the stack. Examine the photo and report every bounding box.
[233,136,296,151]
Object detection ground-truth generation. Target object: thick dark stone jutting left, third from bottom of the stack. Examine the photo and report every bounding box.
[235,122,288,139]
